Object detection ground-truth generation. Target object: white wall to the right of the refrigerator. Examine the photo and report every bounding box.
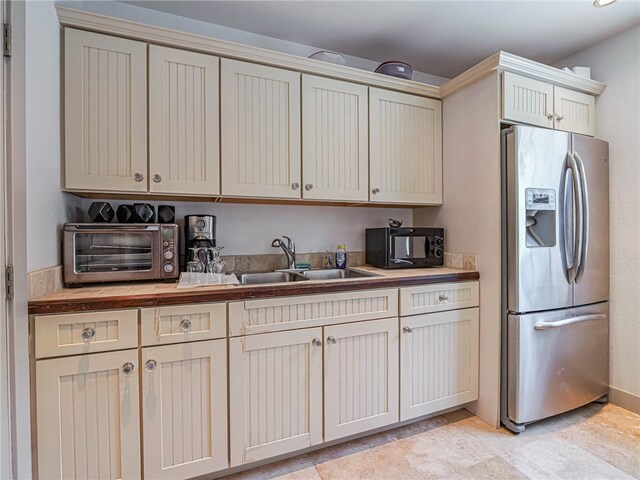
[557,25,640,396]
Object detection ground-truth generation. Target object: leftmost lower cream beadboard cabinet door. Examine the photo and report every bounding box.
[36,349,140,479]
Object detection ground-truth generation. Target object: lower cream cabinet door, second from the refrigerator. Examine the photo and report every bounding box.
[324,318,399,441]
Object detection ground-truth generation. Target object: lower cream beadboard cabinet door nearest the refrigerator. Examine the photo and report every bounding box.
[400,308,479,421]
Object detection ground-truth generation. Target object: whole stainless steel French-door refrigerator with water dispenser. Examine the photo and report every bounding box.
[501,126,609,432]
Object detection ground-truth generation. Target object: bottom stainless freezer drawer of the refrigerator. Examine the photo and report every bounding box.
[507,302,609,424]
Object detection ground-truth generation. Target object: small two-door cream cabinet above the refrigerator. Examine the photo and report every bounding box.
[502,72,596,136]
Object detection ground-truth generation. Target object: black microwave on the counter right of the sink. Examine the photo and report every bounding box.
[365,227,444,268]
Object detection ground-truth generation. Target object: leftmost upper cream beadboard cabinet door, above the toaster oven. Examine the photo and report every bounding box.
[64,28,147,192]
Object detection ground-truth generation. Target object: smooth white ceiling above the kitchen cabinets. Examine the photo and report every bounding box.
[124,0,640,78]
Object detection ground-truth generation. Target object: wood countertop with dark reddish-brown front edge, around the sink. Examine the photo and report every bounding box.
[29,266,480,314]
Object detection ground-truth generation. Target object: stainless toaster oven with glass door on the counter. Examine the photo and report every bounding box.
[63,223,180,285]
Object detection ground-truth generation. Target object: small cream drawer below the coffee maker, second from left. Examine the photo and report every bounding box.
[141,303,227,347]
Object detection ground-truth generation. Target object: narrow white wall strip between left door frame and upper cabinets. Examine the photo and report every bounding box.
[25,2,82,271]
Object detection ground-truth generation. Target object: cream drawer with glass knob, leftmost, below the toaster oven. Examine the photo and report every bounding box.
[35,310,138,358]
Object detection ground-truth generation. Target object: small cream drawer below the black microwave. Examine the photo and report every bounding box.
[400,282,479,317]
